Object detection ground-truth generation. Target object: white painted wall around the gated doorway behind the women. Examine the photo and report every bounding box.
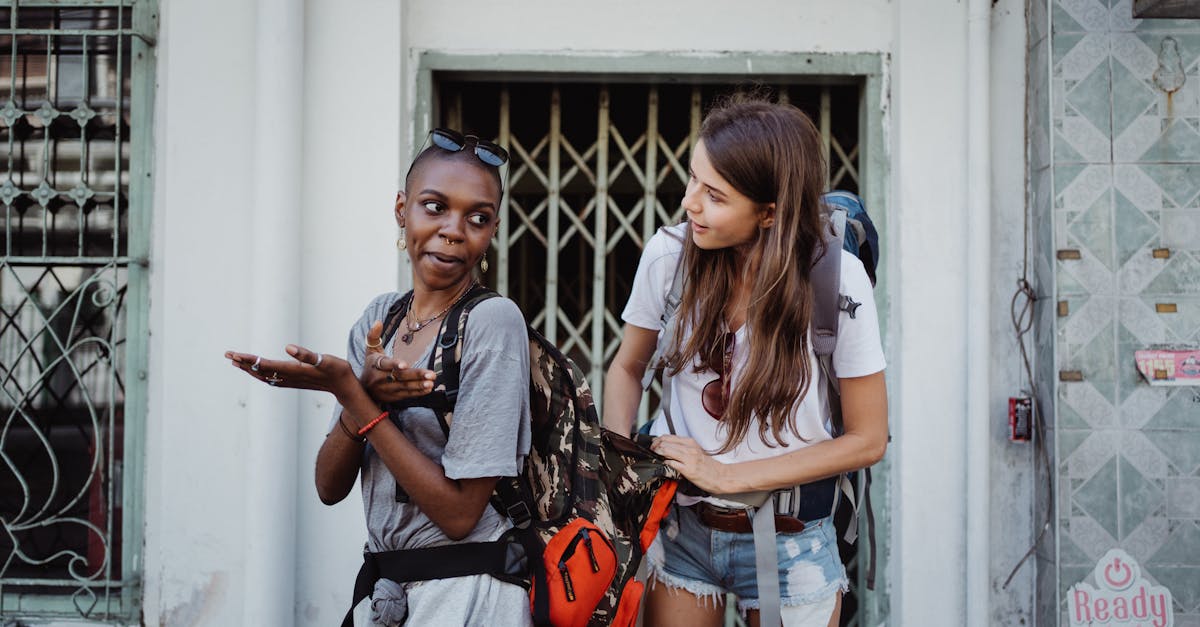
[129,0,1030,626]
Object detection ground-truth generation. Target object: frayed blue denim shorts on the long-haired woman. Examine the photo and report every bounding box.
[647,497,848,611]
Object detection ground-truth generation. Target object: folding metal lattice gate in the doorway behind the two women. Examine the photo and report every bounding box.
[432,78,863,625]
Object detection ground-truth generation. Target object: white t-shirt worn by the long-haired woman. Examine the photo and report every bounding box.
[622,222,887,464]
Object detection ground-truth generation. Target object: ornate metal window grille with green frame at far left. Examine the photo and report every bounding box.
[0,0,156,621]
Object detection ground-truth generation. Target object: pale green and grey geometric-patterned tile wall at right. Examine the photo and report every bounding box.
[1051,0,1200,614]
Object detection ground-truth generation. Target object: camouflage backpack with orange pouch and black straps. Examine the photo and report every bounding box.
[343,286,678,627]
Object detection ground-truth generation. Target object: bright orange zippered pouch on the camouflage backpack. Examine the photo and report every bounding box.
[542,518,617,627]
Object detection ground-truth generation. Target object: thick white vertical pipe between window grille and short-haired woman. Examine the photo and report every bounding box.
[244,0,304,625]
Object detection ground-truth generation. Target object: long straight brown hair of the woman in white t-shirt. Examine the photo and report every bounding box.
[670,95,826,453]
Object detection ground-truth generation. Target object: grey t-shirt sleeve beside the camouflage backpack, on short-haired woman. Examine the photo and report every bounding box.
[442,298,529,479]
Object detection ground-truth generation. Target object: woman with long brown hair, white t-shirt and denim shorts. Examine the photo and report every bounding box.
[604,97,887,627]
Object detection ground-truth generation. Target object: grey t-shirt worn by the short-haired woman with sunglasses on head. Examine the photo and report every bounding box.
[330,292,529,553]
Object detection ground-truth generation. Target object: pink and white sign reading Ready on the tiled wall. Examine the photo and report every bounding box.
[1067,549,1175,627]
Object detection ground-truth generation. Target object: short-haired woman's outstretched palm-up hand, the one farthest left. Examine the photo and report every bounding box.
[226,344,358,396]
